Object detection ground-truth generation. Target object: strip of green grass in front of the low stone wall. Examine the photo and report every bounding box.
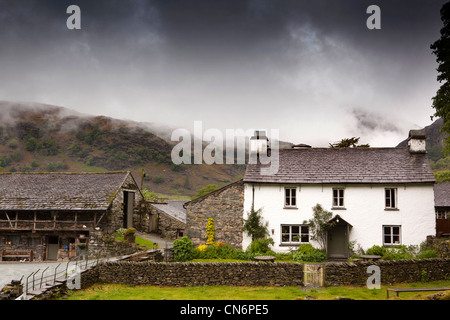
[68,280,450,300]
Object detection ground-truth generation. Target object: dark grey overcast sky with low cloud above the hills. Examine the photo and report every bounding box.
[0,0,446,146]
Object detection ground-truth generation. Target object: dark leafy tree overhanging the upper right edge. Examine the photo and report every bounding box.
[430,2,450,153]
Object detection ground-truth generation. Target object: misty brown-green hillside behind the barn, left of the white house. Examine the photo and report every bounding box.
[0,101,245,197]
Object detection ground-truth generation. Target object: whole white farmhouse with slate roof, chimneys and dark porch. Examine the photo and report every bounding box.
[242,130,436,258]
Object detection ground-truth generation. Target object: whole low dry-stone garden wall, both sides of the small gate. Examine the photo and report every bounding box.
[79,258,450,287]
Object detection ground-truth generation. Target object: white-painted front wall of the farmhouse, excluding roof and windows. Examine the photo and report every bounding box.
[242,183,436,252]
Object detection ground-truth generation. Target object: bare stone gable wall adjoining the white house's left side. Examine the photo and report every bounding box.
[186,180,244,249]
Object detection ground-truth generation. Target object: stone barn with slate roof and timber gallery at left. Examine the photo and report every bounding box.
[0,172,148,261]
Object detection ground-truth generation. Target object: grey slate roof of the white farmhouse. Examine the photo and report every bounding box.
[244,148,435,184]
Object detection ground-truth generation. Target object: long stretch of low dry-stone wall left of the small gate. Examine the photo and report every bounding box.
[96,261,303,286]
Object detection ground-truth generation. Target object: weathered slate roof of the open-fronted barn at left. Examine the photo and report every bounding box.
[0,172,129,210]
